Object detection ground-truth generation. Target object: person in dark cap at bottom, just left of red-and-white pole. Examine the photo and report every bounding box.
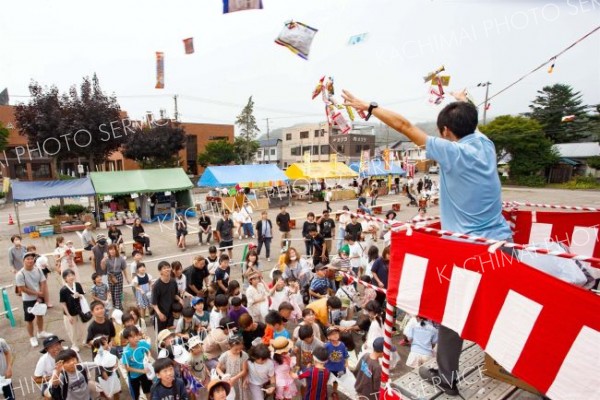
[354,337,396,400]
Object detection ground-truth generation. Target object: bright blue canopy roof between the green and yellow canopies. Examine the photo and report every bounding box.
[198,164,288,187]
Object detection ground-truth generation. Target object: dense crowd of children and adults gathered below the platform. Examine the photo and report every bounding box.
[7,203,437,400]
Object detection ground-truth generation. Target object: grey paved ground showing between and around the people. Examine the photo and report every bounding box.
[0,177,600,399]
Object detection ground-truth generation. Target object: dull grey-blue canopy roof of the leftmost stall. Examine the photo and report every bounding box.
[11,178,96,202]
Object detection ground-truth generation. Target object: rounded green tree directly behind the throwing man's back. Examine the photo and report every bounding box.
[479,115,558,179]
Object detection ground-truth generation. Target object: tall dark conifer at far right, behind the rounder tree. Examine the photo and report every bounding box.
[525,83,597,143]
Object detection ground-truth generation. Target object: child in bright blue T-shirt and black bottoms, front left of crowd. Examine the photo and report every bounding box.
[121,326,152,400]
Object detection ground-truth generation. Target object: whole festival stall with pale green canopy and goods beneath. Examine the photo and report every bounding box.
[90,168,196,225]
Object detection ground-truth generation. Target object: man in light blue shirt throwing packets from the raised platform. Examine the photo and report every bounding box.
[342,91,512,396]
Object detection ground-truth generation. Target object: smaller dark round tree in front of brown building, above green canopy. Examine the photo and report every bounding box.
[123,120,186,169]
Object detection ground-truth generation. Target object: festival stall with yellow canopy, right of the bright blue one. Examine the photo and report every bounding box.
[285,161,358,201]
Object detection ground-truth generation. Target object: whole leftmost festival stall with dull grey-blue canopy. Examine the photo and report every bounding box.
[11,178,95,237]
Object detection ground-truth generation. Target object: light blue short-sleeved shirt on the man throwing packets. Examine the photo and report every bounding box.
[426,131,512,240]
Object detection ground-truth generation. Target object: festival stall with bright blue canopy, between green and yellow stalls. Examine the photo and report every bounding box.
[198,164,289,210]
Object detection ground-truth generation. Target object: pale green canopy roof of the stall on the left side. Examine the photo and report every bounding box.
[90,168,194,195]
